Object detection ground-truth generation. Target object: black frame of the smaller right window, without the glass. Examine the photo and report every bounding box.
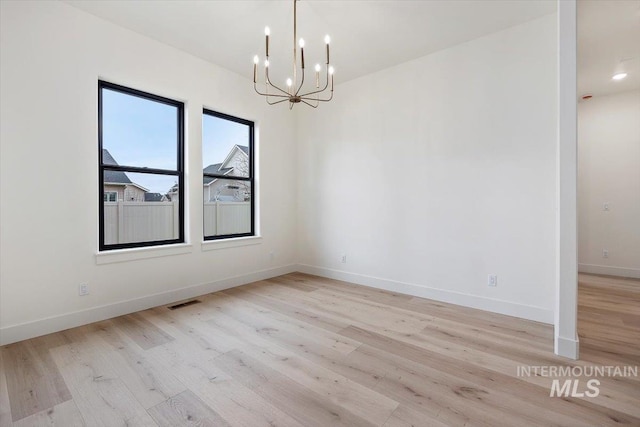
[202,108,256,241]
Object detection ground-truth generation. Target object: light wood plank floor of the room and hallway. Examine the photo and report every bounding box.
[0,274,640,427]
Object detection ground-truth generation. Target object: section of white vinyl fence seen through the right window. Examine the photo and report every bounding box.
[204,202,251,236]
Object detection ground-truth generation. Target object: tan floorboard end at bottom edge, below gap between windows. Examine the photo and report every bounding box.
[149,390,230,427]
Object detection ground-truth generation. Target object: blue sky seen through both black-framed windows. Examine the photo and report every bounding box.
[102,89,249,194]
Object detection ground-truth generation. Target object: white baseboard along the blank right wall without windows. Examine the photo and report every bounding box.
[298,264,553,324]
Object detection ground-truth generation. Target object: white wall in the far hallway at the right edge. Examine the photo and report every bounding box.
[578,90,640,278]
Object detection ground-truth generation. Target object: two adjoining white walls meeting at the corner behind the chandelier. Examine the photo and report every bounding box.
[0,2,568,343]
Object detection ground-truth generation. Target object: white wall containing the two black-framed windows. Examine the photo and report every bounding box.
[0,1,296,343]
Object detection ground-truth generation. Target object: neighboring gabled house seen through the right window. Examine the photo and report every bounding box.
[203,145,251,202]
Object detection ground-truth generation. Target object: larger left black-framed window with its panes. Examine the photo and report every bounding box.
[98,81,184,251]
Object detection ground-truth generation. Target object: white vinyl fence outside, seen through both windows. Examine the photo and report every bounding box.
[104,202,251,245]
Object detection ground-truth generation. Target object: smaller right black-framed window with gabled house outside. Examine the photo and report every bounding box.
[202,110,255,240]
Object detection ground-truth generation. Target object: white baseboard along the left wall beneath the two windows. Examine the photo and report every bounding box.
[0,264,298,345]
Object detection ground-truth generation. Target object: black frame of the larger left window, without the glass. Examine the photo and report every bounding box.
[98,80,185,251]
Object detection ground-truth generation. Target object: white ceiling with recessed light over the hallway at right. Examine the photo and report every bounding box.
[578,0,640,96]
